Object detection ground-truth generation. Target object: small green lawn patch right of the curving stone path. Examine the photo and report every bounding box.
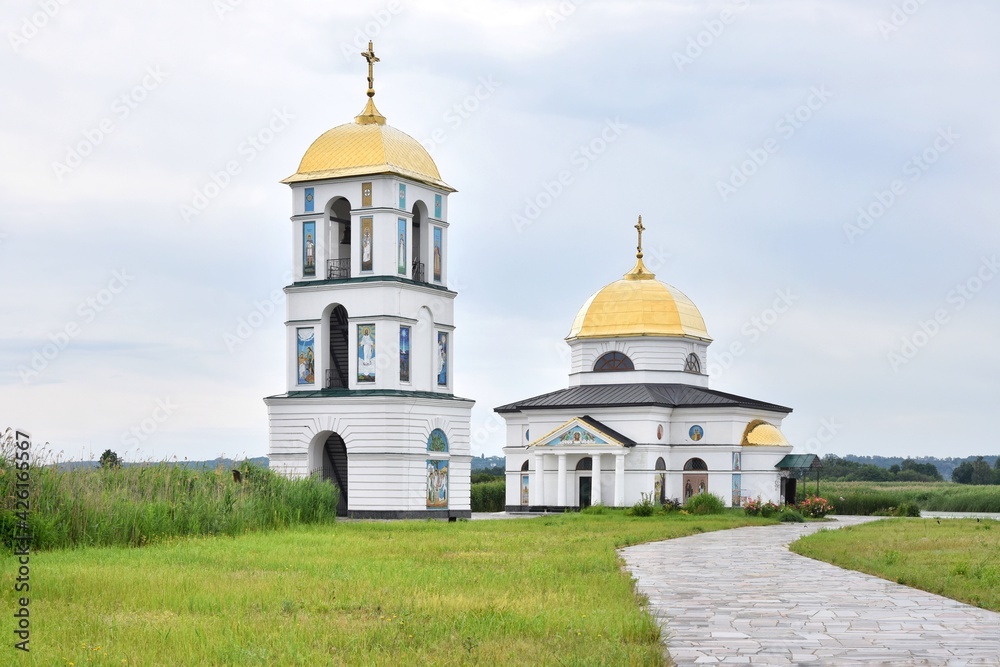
[790,519,1000,611]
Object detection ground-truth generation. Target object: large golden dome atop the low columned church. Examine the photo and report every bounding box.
[566,257,712,342]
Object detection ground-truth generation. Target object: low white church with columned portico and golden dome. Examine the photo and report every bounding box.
[504,217,796,512]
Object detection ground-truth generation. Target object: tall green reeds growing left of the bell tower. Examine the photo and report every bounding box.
[0,461,337,550]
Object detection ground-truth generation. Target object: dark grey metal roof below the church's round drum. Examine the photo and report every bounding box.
[496,383,792,414]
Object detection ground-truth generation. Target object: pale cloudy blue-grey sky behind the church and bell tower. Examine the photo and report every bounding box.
[0,0,1000,460]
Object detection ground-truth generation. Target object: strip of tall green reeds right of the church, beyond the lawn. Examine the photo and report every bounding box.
[820,482,1000,515]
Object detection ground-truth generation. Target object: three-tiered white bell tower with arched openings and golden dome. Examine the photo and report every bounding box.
[264,42,474,519]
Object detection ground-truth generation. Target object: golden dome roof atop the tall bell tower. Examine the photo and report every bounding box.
[282,99,455,192]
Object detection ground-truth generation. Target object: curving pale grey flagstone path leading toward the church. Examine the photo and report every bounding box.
[621,517,1000,665]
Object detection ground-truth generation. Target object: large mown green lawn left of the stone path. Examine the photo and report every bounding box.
[0,512,770,666]
